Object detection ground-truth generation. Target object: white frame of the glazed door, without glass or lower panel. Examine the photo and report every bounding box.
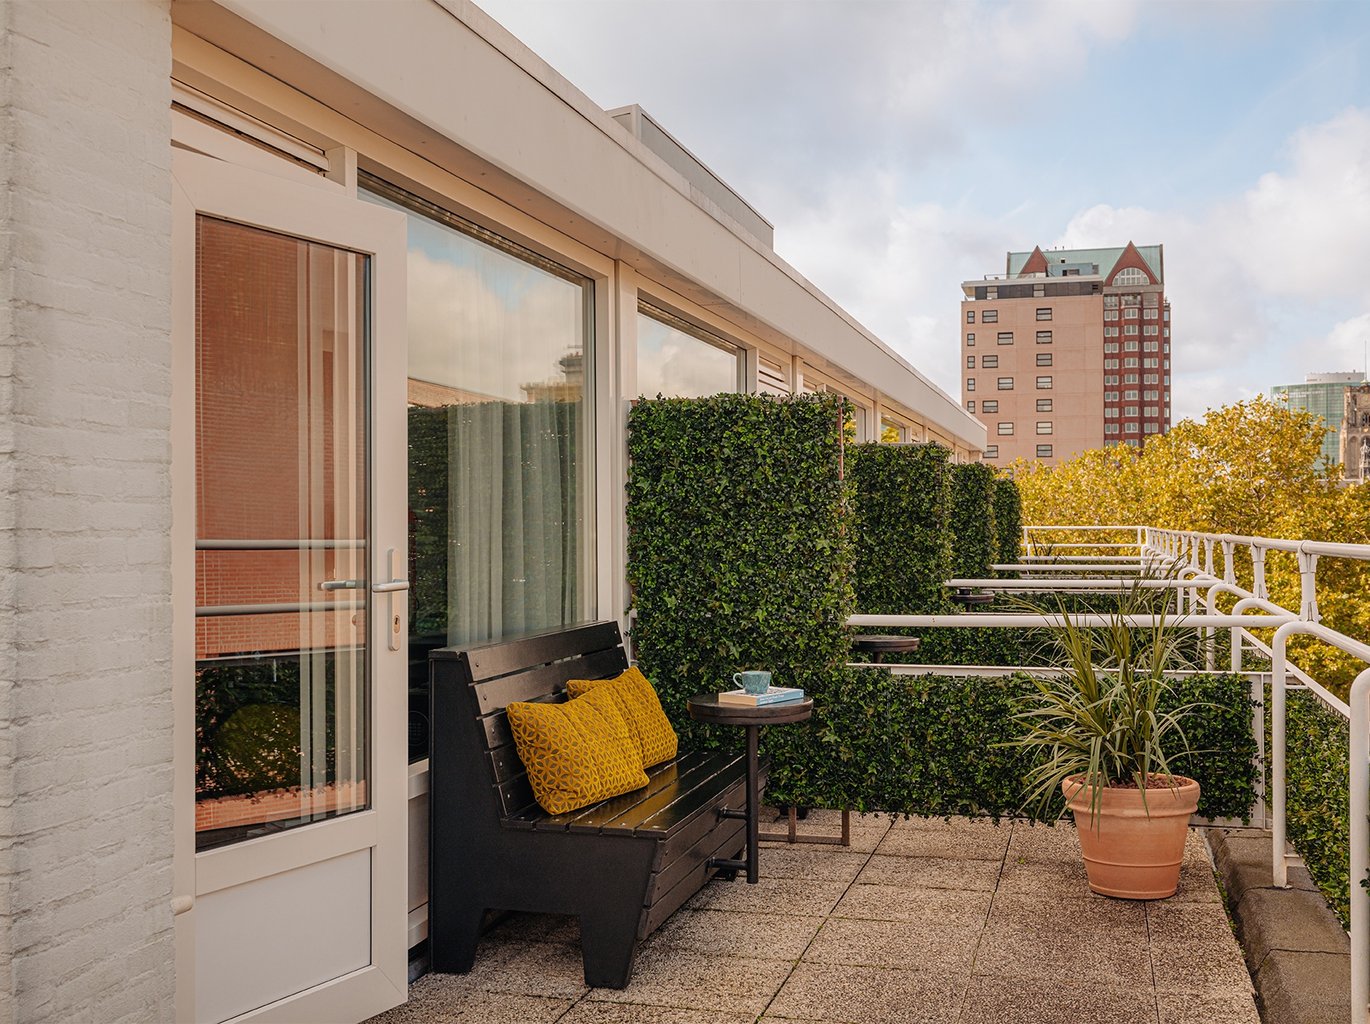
[171,149,408,1024]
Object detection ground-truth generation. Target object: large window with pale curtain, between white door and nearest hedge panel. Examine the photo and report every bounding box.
[366,178,595,757]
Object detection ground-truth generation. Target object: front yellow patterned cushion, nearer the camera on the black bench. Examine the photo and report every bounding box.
[506,692,647,814]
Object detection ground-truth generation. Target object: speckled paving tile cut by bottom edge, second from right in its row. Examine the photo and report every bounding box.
[959,972,1156,1024]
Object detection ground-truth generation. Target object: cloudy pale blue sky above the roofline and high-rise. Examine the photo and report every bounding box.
[477,0,1370,419]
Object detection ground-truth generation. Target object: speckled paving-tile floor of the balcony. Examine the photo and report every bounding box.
[374,812,1259,1024]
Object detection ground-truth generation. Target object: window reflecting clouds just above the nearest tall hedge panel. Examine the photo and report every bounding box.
[637,303,743,398]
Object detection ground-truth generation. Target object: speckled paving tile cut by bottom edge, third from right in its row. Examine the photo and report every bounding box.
[763,962,966,1024]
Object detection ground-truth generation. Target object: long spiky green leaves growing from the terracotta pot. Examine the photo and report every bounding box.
[1010,572,1201,827]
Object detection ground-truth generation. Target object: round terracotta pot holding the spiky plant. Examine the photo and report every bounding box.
[1060,775,1199,899]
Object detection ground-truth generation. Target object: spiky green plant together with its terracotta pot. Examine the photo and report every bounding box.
[1012,573,1199,899]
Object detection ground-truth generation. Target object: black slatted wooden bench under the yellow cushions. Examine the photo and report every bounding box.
[429,622,747,988]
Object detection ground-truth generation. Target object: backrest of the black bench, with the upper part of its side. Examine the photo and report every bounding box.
[429,622,627,818]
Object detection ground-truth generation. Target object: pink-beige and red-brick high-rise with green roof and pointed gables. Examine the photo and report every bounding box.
[960,241,1170,465]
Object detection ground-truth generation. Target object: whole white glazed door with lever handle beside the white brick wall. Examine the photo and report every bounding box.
[174,152,407,1023]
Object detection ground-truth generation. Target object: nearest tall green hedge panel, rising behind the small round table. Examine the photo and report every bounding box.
[627,395,854,779]
